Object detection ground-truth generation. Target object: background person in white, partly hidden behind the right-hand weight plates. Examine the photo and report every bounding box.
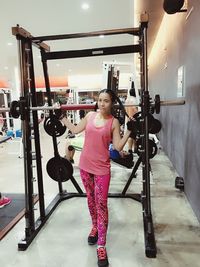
[125,84,138,153]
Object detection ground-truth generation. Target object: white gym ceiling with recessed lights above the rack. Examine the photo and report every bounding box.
[0,0,164,87]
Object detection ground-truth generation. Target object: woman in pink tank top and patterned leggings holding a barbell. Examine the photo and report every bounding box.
[62,89,131,267]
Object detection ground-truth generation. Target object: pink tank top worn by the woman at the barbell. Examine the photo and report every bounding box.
[79,112,114,175]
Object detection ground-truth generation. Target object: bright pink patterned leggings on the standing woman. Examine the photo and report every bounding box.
[80,170,110,246]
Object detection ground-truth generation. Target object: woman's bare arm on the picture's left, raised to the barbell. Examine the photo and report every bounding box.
[61,111,92,134]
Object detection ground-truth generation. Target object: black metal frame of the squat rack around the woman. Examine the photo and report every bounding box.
[12,16,157,258]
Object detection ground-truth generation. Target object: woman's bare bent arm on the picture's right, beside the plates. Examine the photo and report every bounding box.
[112,119,131,151]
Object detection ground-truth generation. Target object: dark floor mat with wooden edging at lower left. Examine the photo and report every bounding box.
[0,193,38,240]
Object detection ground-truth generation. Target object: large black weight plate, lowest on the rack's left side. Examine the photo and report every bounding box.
[46,156,73,182]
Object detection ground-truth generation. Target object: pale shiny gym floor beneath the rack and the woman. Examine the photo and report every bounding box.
[0,125,200,267]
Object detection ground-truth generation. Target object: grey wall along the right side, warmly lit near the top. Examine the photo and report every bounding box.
[149,0,200,221]
